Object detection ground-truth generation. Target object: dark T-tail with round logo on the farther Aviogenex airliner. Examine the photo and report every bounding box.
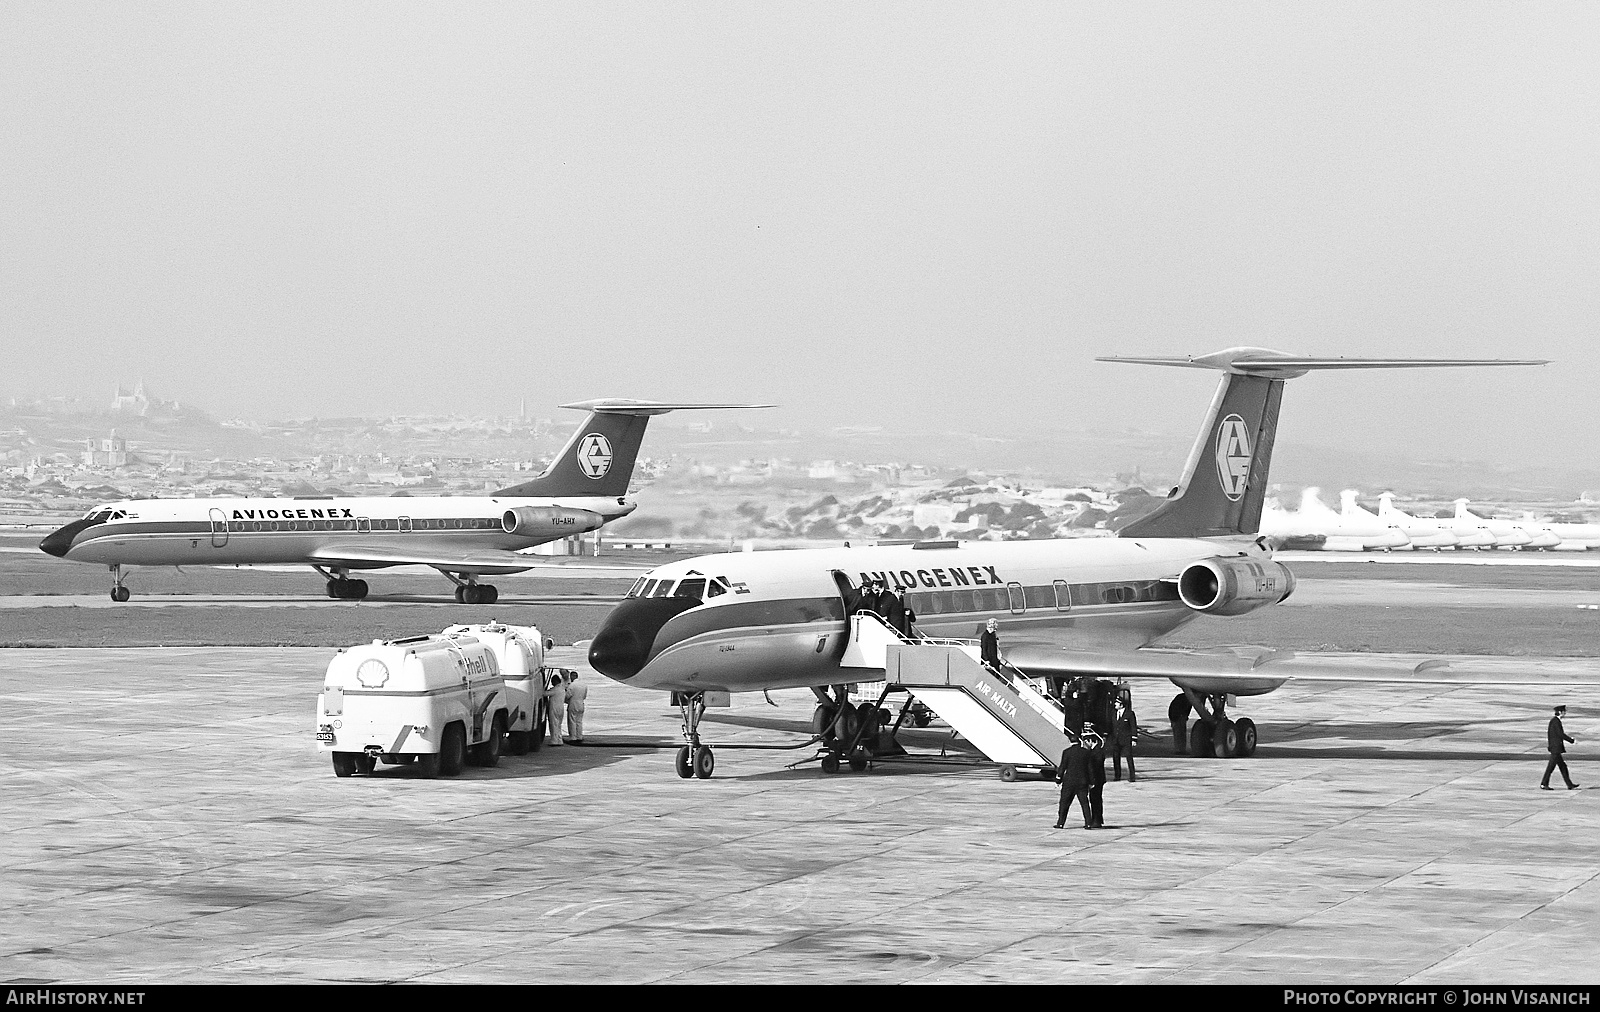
[494,397,773,498]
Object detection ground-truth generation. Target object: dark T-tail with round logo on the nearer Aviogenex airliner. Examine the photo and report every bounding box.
[1096,347,1547,538]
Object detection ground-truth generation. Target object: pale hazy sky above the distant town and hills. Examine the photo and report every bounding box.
[0,0,1600,463]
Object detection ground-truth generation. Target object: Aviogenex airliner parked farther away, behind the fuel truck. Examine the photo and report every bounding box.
[38,399,771,604]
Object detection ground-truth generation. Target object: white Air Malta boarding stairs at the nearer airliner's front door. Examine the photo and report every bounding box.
[840,612,1067,780]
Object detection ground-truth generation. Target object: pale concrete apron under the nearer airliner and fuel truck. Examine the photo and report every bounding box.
[0,649,1600,983]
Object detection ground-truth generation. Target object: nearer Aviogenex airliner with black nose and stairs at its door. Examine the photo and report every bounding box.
[589,347,1587,777]
